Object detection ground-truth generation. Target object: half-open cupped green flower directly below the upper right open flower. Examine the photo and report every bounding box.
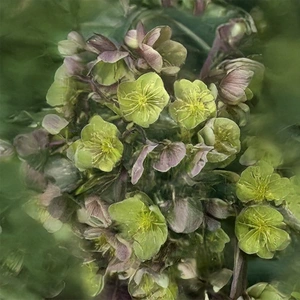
[198,118,241,166]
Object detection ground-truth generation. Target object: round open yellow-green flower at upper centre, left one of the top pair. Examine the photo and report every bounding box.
[118,72,169,128]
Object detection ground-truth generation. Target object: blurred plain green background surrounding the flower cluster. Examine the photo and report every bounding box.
[0,0,300,300]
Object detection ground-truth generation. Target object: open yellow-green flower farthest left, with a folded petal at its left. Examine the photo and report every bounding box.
[67,116,123,172]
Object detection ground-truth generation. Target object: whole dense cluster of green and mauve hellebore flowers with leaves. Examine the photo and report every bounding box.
[0,0,300,300]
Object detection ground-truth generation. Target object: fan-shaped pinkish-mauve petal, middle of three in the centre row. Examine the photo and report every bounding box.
[153,142,186,172]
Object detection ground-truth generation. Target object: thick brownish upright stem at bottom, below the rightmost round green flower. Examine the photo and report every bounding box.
[230,239,247,300]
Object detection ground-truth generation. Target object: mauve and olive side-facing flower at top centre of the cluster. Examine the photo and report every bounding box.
[125,23,187,75]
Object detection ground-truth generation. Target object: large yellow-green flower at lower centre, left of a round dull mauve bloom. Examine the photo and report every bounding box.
[108,193,168,260]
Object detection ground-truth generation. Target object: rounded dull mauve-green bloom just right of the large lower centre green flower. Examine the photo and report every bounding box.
[167,198,203,233]
